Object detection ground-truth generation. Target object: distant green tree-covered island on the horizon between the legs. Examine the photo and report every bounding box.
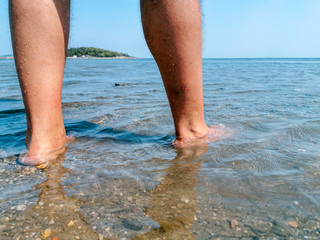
[67,47,130,57]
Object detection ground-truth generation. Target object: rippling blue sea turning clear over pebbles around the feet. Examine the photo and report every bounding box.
[0,58,320,240]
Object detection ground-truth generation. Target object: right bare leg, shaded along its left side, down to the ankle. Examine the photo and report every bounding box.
[140,0,225,148]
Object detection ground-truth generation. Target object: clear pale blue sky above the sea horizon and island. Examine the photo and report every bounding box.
[0,0,320,57]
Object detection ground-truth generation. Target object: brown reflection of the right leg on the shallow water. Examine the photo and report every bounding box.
[137,146,208,239]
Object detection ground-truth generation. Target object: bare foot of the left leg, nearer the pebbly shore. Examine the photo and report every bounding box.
[18,136,74,166]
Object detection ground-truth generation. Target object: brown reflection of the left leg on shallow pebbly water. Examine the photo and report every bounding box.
[32,157,99,239]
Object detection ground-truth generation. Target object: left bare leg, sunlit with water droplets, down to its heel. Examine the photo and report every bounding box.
[9,0,70,165]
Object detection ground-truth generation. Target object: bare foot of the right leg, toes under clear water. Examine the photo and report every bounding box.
[173,124,232,148]
